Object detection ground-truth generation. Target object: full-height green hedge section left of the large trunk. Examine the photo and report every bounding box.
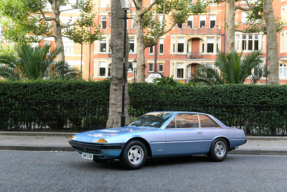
[0,81,110,130]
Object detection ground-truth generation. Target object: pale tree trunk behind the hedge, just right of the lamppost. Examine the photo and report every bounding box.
[135,0,145,82]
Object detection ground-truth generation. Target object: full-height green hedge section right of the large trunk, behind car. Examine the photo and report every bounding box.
[130,84,287,135]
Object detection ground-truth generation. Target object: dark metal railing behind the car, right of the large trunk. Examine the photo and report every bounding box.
[129,104,287,135]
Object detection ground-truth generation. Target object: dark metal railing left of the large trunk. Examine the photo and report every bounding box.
[0,101,109,131]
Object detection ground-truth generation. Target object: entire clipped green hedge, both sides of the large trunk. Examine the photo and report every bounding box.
[0,81,287,134]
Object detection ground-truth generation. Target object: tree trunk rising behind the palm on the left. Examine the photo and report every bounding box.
[51,1,65,61]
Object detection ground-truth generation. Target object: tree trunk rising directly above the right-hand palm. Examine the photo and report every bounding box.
[227,0,235,53]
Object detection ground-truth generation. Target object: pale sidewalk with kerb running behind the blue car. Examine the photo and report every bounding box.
[0,131,287,155]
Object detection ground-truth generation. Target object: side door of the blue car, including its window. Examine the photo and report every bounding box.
[165,113,202,154]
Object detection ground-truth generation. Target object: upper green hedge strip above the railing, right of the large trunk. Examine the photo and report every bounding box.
[129,84,287,105]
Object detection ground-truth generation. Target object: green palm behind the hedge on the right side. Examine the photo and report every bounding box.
[191,51,263,85]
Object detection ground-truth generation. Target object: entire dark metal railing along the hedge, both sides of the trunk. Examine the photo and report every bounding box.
[0,101,287,135]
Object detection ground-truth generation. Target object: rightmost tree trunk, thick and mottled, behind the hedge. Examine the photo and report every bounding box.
[263,0,279,85]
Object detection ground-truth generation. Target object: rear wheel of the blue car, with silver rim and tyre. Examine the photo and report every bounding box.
[208,138,228,162]
